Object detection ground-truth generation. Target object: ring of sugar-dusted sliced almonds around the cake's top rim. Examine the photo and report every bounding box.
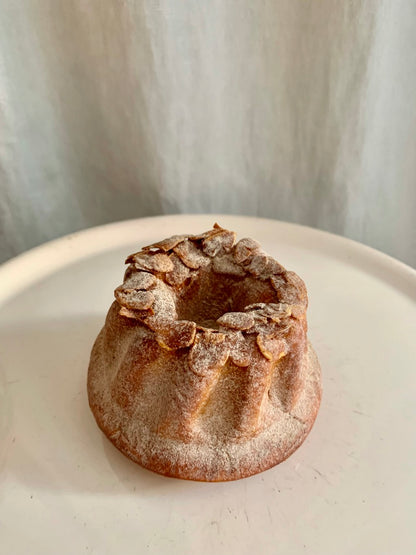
[114,223,308,358]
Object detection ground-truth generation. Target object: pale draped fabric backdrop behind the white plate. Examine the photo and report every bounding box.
[0,0,416,266]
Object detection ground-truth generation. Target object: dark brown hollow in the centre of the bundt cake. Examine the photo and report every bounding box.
[176,267,276,329]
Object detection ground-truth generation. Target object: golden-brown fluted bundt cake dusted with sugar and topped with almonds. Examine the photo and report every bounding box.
[88,224,321,481]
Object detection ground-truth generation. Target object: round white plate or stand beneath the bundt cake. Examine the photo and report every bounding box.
[0,215,416,555]
